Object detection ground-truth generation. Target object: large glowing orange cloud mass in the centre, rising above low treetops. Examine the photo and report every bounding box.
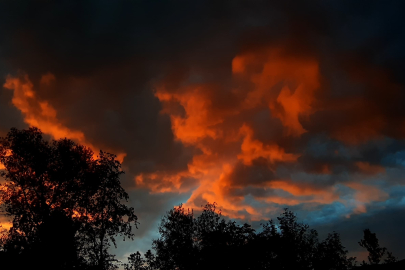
[135,46,350,220]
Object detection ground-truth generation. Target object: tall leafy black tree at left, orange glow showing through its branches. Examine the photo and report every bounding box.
[0,127,137,269]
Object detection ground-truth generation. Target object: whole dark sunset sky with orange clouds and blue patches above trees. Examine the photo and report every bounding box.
[0,0,405,264]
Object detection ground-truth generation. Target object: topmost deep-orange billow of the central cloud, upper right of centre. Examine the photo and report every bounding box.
[232,49,320,136]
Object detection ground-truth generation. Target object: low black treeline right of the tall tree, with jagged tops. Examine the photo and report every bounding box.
[125,203,396,270]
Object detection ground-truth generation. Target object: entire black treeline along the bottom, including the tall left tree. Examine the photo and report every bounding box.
[0,128,396,270]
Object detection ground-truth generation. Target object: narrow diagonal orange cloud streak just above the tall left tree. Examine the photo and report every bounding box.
[3,73,126,162]
